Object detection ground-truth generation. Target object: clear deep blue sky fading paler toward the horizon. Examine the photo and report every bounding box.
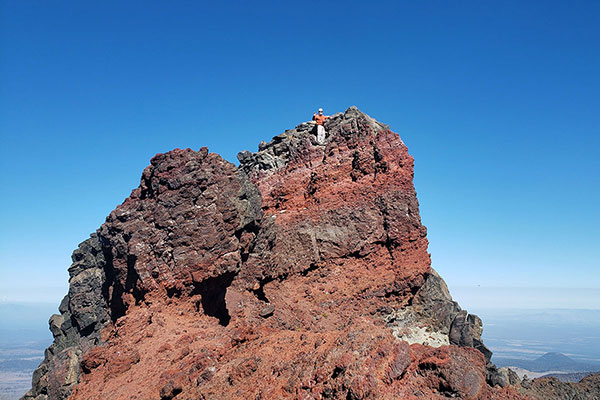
[0,0,600,308]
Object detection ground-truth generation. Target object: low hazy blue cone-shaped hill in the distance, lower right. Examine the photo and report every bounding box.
[494,353,600,372]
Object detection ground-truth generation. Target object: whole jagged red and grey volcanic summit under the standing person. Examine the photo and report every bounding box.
[24,107,584,400]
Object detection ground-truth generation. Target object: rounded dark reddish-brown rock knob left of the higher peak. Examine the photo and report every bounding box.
[98,148,262,320]
